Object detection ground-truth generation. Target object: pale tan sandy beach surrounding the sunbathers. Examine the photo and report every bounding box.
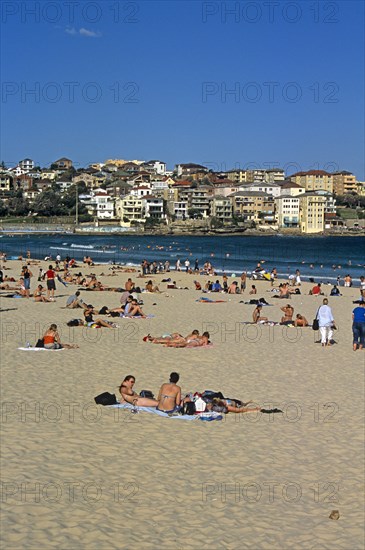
[0,261,365,550]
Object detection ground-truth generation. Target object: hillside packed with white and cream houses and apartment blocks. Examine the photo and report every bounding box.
[0,157,365,234]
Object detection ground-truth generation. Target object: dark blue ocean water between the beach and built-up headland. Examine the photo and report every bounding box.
[0,234,365,282]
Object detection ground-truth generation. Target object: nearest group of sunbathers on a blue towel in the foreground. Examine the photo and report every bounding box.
[119,372,262,415]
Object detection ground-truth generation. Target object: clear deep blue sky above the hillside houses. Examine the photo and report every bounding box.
[0,0,365,180]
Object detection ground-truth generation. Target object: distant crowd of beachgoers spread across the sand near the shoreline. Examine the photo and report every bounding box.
[0,251,365,351]
